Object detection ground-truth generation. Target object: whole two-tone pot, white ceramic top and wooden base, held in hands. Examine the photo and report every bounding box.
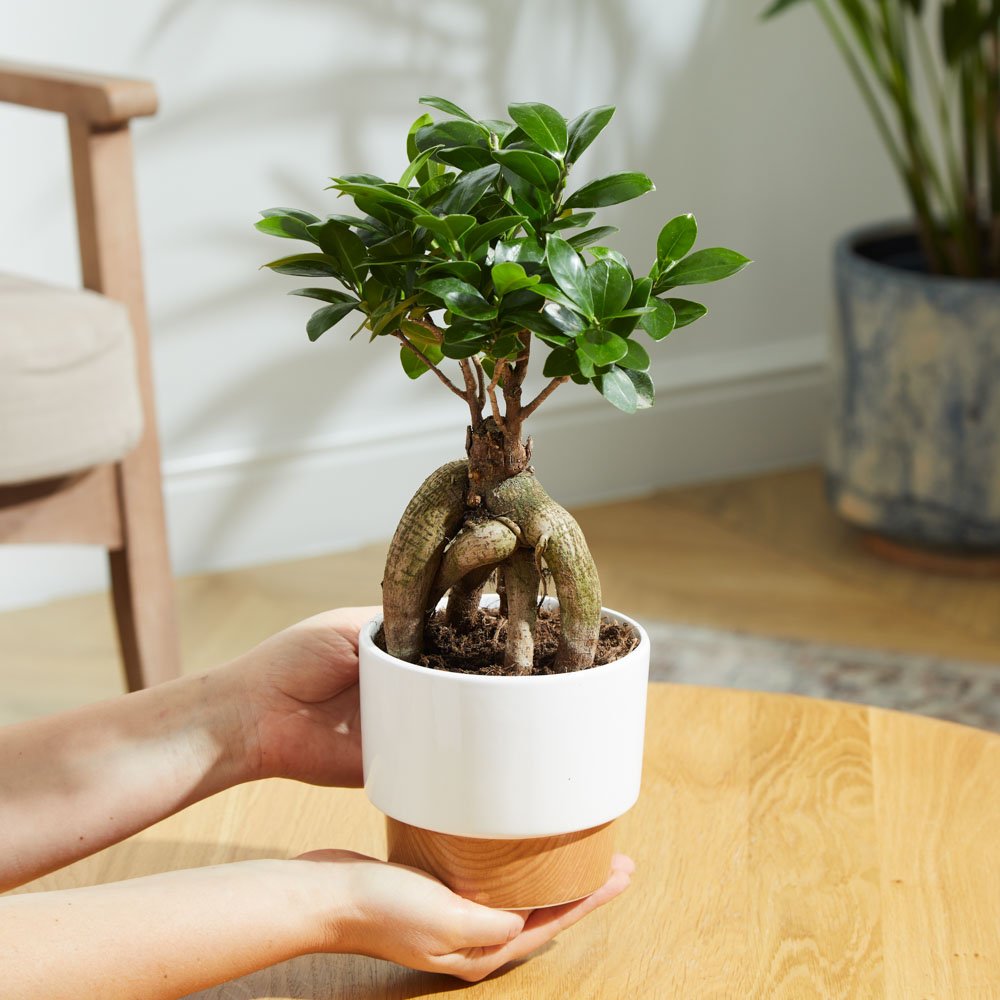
[359,596,649,909]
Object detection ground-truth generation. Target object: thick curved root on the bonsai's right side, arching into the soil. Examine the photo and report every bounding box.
[485,472,601,671]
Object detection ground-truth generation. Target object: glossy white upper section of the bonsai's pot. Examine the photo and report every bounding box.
[359,595,649,840]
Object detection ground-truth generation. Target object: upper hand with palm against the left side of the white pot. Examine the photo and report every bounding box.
[226,607,381,788]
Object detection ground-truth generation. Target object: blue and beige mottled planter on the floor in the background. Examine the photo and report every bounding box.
[827,227,1000,549]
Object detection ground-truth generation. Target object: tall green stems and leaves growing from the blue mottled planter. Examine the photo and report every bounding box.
[764,0,1000,278]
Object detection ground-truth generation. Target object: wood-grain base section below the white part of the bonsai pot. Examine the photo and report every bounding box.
[386,816,614,910]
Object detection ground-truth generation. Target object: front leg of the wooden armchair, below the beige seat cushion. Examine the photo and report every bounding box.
[108,445,180,691]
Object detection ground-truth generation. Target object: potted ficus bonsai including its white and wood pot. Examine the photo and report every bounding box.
[257,97,748,906]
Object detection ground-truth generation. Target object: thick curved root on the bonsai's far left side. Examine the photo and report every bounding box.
[382,461,468,662]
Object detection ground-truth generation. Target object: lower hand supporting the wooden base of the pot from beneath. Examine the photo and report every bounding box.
[299,851,635,982]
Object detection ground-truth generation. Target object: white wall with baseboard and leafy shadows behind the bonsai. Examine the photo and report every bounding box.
[0,0,902,606]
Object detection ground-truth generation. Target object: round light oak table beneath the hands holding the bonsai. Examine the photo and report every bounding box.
[21,684,1000,1000]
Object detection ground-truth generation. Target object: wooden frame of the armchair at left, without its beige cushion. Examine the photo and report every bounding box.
[0,62,179,690]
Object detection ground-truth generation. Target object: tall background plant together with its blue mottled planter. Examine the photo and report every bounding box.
[765,0,1000,548]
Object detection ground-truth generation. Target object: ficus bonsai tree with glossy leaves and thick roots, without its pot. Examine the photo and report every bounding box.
[257,97,749,674]
